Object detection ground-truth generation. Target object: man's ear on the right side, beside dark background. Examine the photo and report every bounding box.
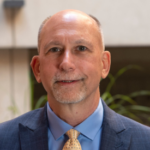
[102,51,111,79]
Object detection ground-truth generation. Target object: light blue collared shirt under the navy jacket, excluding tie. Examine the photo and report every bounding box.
[47,99,103,150]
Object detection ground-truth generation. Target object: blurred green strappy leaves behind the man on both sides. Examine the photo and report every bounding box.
[32,65,150,123]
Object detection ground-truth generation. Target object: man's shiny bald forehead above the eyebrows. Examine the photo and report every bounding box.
[41,13,100,47]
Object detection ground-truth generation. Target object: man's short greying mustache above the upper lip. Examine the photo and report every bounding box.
[53,73,86,82]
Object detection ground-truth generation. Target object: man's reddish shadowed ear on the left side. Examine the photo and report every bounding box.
[30,55,41,83]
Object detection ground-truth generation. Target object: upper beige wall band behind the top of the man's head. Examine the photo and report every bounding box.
[0,0,150,48]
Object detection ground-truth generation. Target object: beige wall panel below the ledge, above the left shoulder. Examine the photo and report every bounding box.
[0,49,30,122]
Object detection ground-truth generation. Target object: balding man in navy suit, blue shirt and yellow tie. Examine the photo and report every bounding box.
[0,10,150,150]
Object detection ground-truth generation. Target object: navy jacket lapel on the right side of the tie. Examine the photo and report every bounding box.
[100,101,131,150]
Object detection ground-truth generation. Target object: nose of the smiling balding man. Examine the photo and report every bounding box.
[59,50,75,72]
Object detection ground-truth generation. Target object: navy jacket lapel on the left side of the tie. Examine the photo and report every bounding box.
[19,105,48,150]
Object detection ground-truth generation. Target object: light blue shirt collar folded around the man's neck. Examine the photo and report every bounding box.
[47,99,103,140]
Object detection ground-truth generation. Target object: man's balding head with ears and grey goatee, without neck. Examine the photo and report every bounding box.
[31,10,110,103]
